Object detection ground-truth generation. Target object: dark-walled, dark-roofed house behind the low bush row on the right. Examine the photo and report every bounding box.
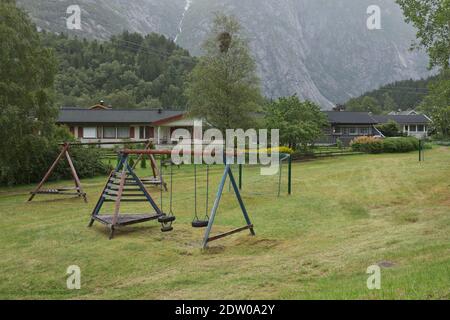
[316,111,431,145]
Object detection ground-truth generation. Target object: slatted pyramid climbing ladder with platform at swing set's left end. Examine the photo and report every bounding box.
[89,150,175,239]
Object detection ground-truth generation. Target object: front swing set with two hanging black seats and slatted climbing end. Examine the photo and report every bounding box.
[89,149,291,248]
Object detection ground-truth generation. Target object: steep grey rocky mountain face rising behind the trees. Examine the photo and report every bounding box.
[18,0,430,109]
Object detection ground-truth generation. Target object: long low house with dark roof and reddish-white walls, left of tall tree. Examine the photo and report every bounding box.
[57,105,194,146]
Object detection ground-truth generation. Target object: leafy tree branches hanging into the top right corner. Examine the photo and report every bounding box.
[397,0,450,69]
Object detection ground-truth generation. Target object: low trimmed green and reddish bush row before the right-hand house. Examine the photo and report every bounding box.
[351,137,419,153]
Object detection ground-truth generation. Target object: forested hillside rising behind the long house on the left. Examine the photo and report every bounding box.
[41,32,196,109]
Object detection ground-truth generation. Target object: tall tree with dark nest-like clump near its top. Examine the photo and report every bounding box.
[186,14,262,132]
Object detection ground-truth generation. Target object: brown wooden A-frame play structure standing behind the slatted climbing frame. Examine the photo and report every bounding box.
[28,140,163,202]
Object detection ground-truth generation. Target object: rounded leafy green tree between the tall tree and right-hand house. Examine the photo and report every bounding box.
[265,95,328,150]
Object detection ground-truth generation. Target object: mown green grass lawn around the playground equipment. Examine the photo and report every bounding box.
[0,147,450,299]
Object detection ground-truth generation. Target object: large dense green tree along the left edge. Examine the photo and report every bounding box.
[0,1,57,183]
